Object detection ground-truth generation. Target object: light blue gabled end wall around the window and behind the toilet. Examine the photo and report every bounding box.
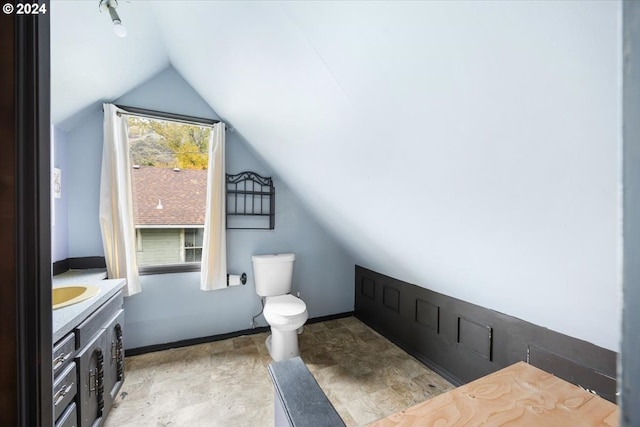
[68,68,354,348]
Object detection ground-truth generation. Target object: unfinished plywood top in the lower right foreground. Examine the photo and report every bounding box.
[370,362,618,427]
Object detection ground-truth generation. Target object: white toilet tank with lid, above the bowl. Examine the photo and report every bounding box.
[251,254,296,297]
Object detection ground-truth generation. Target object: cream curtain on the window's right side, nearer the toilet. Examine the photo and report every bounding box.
[200,122,227,291]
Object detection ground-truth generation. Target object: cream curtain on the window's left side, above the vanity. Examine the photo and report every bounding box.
[100,104,142,295]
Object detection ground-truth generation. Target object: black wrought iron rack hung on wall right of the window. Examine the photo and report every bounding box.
[226,171,276,230]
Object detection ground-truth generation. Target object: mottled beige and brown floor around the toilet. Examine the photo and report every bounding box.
[105,317,453,427]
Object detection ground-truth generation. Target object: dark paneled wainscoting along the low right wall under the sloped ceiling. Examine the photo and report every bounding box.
[355,266,617,402]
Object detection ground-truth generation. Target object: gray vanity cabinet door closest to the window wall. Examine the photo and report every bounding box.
[104,310,124,412]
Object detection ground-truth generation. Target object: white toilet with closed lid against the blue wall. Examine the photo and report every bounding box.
[251,254,309,362]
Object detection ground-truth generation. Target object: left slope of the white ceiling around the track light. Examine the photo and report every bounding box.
[51,0,169,130]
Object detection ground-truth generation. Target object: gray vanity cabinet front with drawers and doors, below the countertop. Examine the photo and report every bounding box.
[54,291,124,427]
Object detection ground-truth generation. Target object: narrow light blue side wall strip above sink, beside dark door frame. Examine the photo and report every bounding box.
[51,126,71,262]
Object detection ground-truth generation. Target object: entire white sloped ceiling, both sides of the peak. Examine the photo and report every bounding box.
[52,0,621,349]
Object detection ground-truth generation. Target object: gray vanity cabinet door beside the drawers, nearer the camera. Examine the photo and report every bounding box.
[75,329,109,427]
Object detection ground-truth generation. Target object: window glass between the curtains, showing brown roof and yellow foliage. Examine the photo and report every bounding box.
[127,116,211,274]
